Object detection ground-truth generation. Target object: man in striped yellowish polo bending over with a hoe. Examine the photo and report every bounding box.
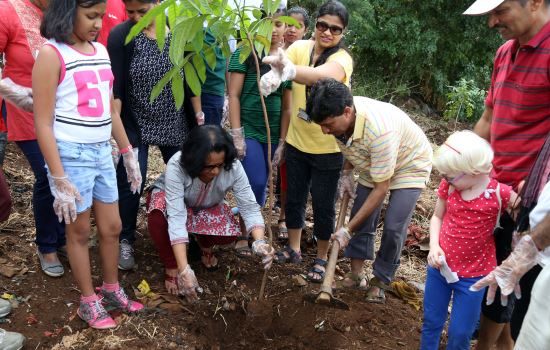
[306,79,432,303]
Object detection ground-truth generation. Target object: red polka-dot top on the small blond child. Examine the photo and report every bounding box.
[437,179,512,278]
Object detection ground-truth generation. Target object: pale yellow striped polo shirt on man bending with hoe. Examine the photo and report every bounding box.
[337,96,432,190]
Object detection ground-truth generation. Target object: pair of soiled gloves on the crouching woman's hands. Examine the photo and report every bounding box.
[178,239,275,302]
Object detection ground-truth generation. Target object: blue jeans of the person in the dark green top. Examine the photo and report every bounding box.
[241,138,277,207]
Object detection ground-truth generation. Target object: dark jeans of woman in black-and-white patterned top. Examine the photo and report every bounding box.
[116,145,180,243]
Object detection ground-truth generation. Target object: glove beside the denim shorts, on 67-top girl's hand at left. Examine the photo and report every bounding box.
[48,174,82,224]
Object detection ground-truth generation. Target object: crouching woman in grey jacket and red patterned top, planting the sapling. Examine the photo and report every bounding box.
[147,125,274,299]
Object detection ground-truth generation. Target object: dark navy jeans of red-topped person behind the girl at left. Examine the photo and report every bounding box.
[16,140,65,254]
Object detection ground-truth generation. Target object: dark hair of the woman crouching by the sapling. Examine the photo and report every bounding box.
[180,125,237,178]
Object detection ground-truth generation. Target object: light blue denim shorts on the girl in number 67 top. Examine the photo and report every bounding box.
[53,140,118,214]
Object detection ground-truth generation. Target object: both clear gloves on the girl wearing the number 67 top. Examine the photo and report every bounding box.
[48,148,142,224]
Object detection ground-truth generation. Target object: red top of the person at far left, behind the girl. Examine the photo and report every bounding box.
[0,0,46,141]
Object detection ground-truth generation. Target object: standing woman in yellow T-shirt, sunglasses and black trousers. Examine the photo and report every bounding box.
[261,1,353,282]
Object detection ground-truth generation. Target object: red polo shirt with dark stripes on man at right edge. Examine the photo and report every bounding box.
[485,22,550,188]
